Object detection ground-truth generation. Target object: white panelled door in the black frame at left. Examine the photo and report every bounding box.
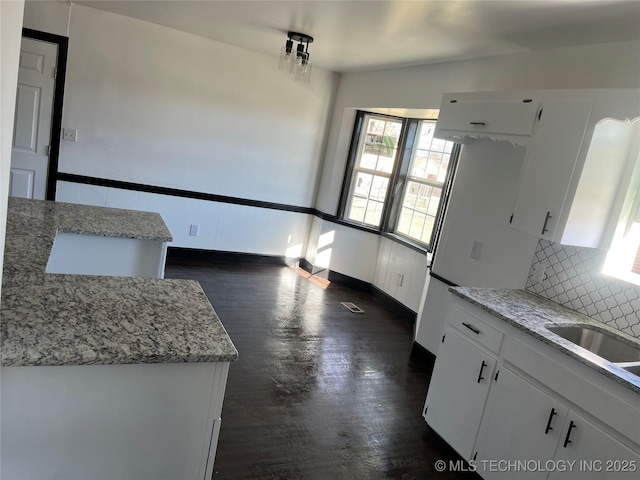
[9,37,58,200]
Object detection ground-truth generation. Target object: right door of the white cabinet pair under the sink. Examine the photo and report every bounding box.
[549,412,640,480]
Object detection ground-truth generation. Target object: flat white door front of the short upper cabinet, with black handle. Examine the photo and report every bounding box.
[436,100,538,136]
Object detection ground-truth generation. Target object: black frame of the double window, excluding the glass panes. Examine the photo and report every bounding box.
[336,110,461,253]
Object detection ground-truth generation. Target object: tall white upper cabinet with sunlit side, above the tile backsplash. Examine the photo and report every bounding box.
[511,90,640,250]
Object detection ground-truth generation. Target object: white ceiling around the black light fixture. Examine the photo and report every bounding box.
[74,0,640,72]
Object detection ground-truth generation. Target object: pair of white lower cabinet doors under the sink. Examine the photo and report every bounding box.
[474,367,640,480]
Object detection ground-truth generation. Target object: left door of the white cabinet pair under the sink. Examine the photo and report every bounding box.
[475,368,568,479]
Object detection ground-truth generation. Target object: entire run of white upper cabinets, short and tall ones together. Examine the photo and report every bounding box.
[436,89,640,250]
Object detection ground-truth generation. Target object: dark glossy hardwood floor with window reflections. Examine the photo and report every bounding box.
[166,263,479,480]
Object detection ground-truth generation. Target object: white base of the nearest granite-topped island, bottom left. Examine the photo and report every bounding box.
[1,362,229,480]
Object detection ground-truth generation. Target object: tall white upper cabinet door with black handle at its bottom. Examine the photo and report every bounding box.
[511,102,591,241]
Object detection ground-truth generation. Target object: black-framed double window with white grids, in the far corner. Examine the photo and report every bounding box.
[338,112,459,250]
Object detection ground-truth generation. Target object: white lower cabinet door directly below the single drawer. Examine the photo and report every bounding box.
[425,330,496,459]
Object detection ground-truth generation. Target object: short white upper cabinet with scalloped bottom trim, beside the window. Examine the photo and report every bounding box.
[435,94,539,145]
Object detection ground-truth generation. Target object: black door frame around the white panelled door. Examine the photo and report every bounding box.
[22,28,69,200]
